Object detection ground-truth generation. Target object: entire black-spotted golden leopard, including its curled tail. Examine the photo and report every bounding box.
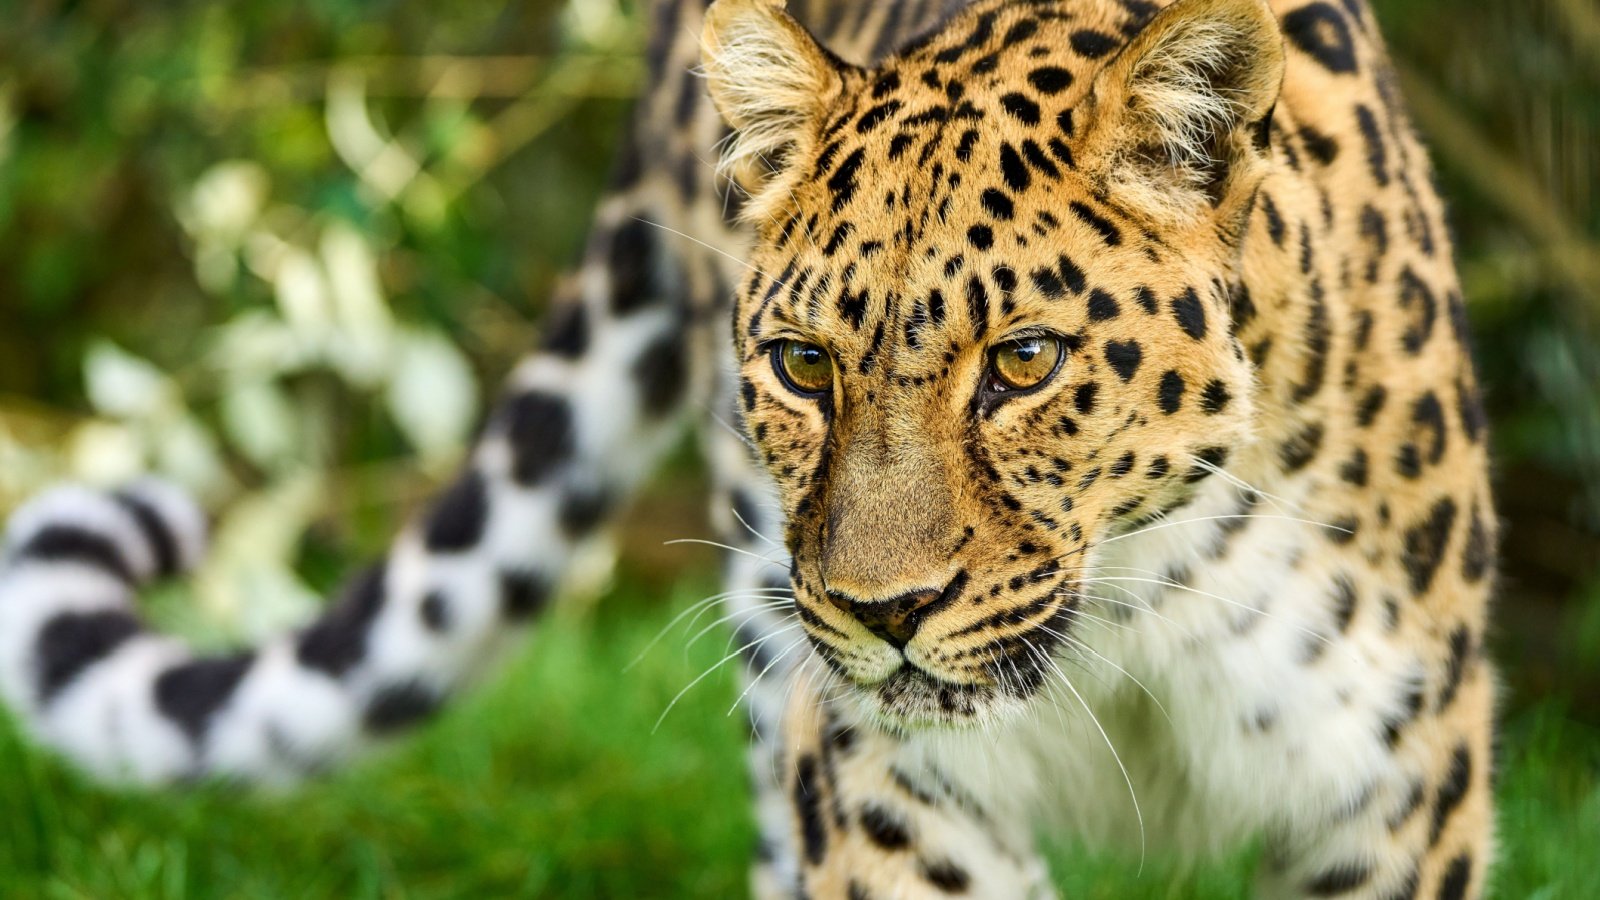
[0,0,1496,900]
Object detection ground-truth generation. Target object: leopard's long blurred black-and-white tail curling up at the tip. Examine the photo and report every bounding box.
[0,119,725,783]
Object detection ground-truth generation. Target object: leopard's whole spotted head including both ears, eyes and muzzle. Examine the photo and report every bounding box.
[704,0,1283,727]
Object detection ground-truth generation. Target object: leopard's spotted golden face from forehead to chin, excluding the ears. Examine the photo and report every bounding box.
[714,0,1280,727]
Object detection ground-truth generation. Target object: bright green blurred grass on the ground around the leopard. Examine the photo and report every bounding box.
[0,570,1600,900]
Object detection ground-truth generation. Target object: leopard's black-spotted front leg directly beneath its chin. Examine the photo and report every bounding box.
[758,666,1054,900]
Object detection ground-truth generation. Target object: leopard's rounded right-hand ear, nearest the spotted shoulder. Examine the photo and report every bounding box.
[1078,0,1283,223]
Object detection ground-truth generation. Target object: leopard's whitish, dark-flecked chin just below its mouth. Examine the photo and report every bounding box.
[851,663,1027,732]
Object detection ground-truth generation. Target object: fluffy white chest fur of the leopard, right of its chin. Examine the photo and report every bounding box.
[907,479,1414,855]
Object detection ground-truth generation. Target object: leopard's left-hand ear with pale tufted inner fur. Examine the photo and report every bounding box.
[701,0,851,211]
